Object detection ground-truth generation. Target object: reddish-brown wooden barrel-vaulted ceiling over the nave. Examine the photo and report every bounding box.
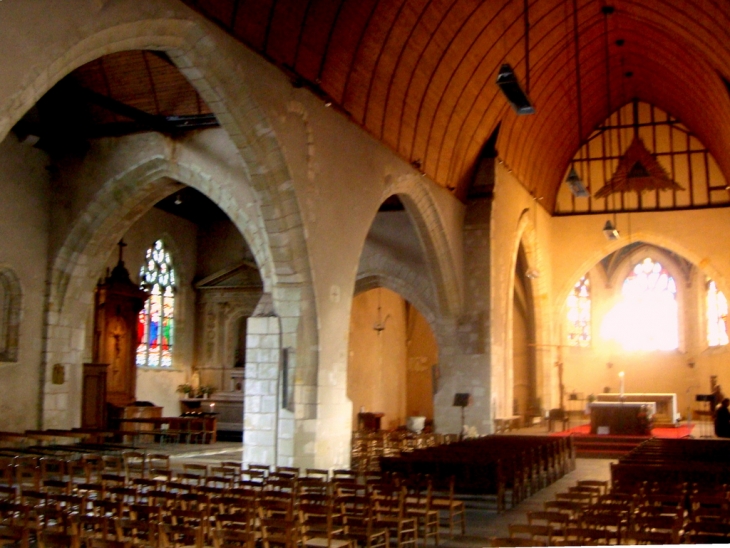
[184,0,730,211]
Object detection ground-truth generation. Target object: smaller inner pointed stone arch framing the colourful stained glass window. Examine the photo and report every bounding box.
[44,150,282,426]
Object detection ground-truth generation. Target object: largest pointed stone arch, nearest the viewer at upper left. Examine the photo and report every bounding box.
[0,19,309,300]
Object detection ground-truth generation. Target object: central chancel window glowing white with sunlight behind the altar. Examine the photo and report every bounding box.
[601,257,679,350]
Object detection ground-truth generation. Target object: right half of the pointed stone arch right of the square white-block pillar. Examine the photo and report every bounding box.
[381,176,463,318]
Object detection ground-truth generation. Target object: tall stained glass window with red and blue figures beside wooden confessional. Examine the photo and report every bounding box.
[137,240,175,367]
